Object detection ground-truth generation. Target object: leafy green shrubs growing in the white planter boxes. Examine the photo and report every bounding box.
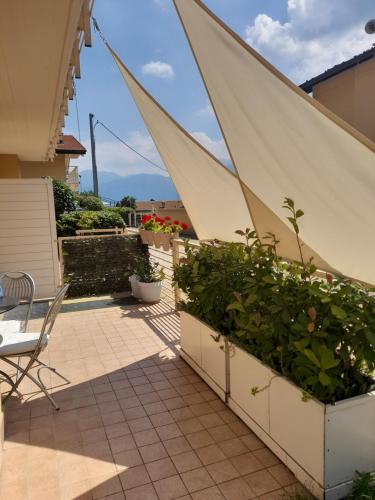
[174,198,375,403]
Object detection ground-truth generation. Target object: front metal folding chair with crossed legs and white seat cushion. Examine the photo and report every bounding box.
[0,284,69,410]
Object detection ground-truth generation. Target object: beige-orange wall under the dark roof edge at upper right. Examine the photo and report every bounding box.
[313,58,375,145]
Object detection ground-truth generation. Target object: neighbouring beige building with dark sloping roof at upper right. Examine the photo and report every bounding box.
[300,48,375,142]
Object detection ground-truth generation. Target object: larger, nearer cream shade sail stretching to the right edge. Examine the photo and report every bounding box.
[174,0,375,283]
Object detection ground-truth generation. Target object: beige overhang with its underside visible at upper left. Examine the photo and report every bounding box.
[0,0,92,161]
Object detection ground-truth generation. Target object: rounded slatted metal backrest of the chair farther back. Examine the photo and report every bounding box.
[0,271,35,331]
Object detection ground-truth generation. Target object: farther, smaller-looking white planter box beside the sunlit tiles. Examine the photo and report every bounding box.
[180,311,227,400]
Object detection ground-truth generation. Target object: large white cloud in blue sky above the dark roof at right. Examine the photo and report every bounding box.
[245,0,375,83]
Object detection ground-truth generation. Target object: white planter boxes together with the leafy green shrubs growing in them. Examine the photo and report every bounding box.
[174,199,375,499]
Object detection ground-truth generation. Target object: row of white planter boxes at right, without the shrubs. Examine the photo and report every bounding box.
[181,312,375,500]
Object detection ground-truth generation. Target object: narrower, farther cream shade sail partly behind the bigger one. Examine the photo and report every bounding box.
[107,45,253,241]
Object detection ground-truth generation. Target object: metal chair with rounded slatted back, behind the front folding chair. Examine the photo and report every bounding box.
[0,272,35,334]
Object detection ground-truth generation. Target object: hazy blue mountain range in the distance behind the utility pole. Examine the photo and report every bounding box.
[80,170,180,200]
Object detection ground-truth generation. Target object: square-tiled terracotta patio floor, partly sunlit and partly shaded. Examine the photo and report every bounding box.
[0,303,306,500]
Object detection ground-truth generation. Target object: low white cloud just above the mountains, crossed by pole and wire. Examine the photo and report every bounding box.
[74,131,167,175]
